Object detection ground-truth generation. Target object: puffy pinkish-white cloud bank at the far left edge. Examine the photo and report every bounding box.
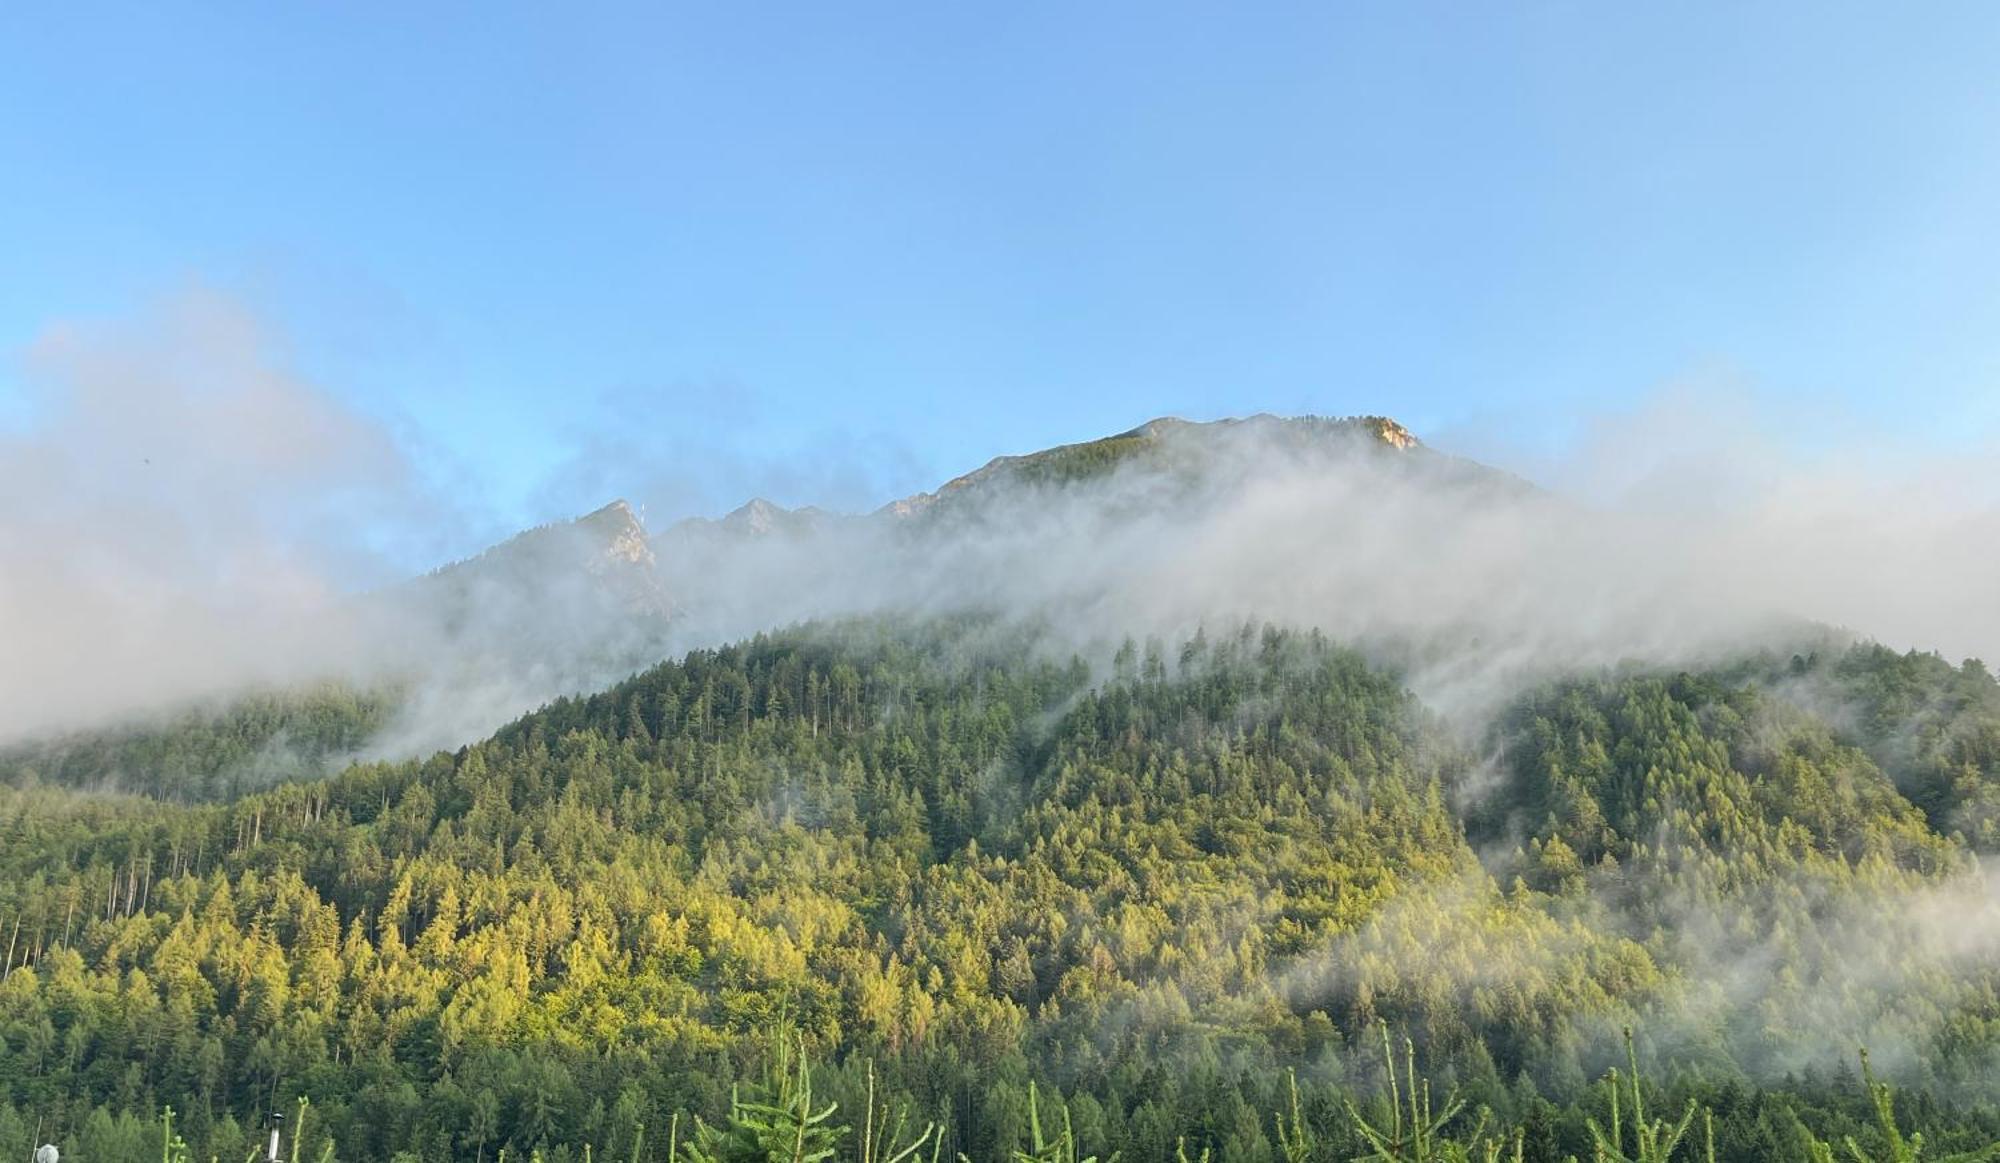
[0,292,426,737]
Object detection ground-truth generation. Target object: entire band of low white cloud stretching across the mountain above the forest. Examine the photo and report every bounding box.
[0,294,2000,747]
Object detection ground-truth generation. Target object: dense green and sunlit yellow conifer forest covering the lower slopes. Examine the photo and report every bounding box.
[0,619,2000,1163]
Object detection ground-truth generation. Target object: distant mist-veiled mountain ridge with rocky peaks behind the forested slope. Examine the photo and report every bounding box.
[0,416,1712,791]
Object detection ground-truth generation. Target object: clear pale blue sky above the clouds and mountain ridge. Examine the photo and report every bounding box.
[0,2,2000,547]
